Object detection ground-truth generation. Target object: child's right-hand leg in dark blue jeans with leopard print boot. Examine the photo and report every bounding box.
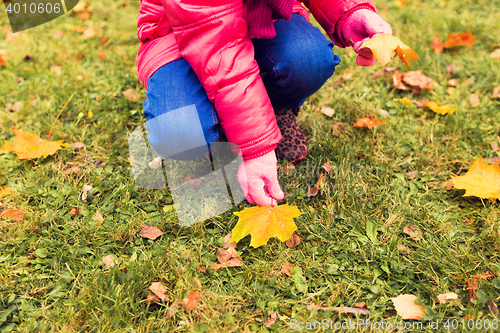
[252,14,340,161]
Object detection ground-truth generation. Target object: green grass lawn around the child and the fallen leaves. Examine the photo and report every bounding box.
[0,0,500,332]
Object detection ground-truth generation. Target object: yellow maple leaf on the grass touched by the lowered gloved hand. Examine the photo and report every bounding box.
[230,204,302,247]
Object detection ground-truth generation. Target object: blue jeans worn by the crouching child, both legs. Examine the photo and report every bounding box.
[144,14,340,160]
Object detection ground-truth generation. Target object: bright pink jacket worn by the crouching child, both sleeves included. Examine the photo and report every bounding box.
[137,0,377,159]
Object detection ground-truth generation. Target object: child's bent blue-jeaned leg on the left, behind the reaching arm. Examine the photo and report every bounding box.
[144,59,219,160]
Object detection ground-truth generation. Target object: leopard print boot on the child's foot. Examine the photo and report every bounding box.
[274,108,307,163]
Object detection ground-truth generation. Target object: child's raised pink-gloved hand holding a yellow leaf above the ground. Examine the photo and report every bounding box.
[342,9,392,66]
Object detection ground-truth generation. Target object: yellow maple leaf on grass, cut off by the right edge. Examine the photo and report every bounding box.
[449,157,500,200]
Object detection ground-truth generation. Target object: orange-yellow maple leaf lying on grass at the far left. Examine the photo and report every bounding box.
[0,128,68,160]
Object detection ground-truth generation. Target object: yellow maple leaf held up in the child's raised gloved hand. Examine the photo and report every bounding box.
[360,33,420,69]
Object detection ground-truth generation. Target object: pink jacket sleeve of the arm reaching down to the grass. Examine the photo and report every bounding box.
[162,0,282,159]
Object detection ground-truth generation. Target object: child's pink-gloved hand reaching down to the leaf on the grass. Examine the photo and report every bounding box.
[238,150,285,206]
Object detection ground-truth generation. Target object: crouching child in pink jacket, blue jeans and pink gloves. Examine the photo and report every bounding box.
[137,0,392,206]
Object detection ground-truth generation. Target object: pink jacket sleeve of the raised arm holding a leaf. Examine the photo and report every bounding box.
[302,0,378,47]
